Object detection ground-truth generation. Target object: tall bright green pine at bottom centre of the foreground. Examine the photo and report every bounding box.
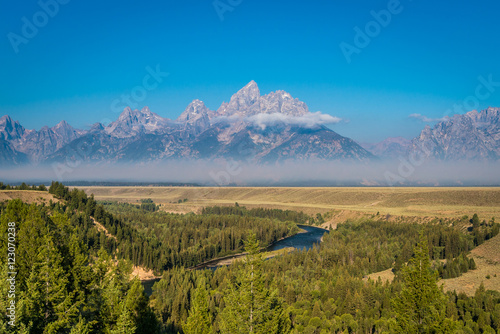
[220,234,290,334]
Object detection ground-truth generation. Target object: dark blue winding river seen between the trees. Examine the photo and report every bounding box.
[142,225,329,296]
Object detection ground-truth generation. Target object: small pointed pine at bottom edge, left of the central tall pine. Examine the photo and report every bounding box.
[182,278,212,334]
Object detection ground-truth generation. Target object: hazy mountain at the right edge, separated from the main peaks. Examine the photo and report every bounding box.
[409,108,500,161]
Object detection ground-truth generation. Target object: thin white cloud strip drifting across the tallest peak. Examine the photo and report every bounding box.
[215,111,342,130]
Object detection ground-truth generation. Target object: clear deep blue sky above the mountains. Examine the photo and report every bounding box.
[0,0,500,141]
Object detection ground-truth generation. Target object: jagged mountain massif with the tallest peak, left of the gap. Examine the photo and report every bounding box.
[0,81,373,164]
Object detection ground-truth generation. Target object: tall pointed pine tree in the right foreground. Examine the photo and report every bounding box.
[393,233,446,333]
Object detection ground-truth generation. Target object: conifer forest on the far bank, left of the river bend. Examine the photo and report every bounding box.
[45,182,298,273]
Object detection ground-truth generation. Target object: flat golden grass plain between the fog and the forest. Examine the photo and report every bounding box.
[81,187,500,218]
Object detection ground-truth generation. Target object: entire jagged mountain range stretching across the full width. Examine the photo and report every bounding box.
[0,81,500,166]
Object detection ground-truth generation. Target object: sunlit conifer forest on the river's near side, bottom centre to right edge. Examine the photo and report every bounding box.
[151,215,500,333]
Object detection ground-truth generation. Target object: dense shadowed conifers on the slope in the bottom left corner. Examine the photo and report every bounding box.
[0,199,160,334]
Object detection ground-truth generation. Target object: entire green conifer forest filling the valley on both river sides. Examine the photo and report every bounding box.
[0,183,500,334]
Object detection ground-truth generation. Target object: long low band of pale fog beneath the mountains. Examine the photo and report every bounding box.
[0,159,500,186]
